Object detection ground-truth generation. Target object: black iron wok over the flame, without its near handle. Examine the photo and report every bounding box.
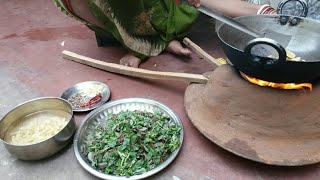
[217,15,320,83]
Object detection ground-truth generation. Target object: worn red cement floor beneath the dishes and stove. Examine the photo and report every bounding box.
[0,0,320,180]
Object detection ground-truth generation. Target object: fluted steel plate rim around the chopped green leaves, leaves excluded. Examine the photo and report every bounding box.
[73,98,183,180]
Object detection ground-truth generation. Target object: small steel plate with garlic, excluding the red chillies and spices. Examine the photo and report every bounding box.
[61,81,110,112]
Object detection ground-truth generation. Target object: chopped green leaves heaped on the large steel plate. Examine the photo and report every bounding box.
[81,111,181,177]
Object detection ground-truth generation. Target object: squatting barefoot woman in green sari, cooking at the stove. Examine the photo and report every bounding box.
[53,0,276,67]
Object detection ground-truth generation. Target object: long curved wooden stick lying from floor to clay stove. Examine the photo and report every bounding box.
[62,50,208,84]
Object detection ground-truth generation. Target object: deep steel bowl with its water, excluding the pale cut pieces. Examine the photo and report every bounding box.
[0,97,76,160]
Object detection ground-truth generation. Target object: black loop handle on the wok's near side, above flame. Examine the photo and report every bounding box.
[244,38,287,69]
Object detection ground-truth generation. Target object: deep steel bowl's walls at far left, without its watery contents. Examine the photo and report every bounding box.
[0,97,76,160]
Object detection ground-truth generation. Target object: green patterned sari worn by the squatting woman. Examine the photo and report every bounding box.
[54,0,199,59]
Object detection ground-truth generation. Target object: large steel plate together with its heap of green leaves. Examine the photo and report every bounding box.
[74,98,183,179]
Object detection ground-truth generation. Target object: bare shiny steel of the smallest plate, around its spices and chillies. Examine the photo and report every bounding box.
[61,81,110,112]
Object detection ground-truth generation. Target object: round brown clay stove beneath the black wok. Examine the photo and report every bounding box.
[184,65,320,166]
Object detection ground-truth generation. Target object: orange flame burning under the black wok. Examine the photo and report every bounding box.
[240,72,312,91]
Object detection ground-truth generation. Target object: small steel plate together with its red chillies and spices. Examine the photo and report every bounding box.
[61,81,110,112]
